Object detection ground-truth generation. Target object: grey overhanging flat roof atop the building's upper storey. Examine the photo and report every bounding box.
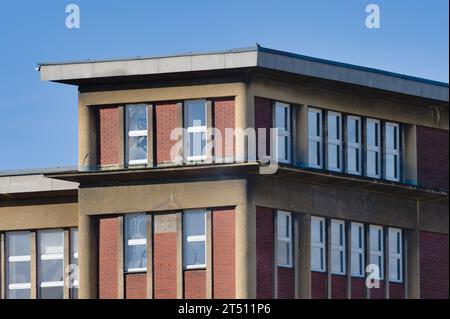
[37,45,449,102]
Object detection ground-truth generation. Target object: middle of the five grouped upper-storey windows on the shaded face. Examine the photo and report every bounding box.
[347,116,361,175]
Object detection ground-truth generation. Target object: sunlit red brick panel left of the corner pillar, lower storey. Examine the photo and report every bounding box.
[212,208,236,298]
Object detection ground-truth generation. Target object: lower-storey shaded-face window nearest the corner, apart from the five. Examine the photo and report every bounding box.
[277,211,292,267]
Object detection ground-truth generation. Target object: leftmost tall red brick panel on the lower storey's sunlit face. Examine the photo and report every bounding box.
[98,217,119,299]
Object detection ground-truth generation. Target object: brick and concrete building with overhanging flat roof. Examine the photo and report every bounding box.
[0,46,449,298]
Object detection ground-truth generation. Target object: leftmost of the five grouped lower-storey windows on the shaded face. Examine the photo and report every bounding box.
[311,217,325,272]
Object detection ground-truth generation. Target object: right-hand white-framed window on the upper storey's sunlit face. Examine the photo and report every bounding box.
[184,100,207,161]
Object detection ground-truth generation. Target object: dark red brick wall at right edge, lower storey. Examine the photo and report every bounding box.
[419,232,449,299]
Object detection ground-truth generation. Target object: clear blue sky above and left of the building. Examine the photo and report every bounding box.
[0,0,449,171]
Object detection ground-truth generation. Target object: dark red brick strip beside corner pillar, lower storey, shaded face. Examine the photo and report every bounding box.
[256,207,274,299]
